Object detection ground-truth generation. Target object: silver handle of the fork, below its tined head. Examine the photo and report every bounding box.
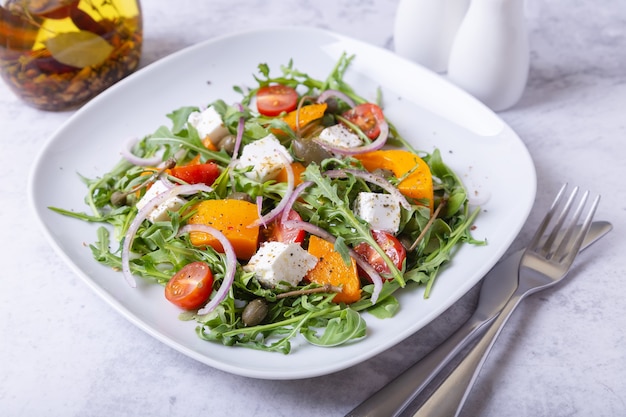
[413,289,528,417]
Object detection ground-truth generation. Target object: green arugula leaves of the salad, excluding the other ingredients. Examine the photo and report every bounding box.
[51,55,484,354]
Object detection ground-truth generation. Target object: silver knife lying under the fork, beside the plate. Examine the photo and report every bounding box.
[346,221,613,417]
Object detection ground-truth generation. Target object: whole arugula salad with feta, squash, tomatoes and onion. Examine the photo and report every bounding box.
[51,55,484,353]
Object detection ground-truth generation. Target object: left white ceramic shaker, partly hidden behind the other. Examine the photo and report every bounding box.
[394,0,469,72]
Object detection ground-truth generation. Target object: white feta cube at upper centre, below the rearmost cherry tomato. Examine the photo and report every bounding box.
[238,133,293,182]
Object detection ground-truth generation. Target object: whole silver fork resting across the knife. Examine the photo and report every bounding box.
[414,184,600,417]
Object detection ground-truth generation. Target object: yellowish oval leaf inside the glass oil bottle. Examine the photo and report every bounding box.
[46,30,113,68]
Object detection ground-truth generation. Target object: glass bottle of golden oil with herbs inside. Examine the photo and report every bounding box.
[0,0,143,110]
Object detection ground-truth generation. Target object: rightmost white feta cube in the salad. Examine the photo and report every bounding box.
[354,193,401,233]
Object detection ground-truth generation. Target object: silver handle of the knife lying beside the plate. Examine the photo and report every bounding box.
[346,313,495,417]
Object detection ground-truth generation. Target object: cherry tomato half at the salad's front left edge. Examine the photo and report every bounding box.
[165,262,213,310]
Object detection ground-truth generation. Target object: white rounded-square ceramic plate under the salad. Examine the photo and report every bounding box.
[30,28,536,379]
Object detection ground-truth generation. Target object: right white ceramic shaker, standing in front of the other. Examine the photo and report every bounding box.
[448,0,530,111]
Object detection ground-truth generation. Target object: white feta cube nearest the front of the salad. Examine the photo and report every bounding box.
[243,242,317,288]
